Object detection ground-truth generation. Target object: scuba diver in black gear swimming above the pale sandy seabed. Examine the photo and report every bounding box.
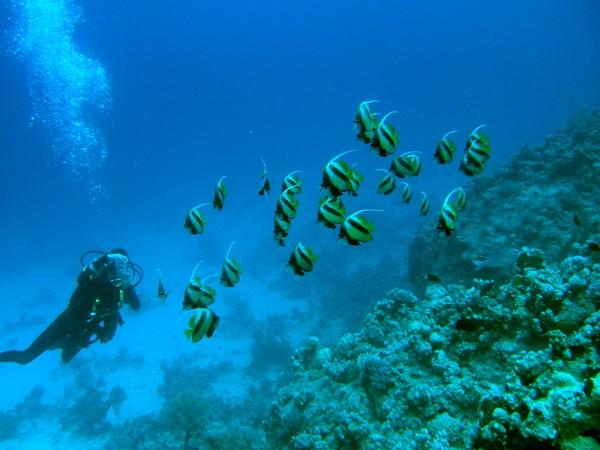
[0,248,144,364]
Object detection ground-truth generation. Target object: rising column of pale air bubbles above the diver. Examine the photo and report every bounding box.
[12,0,111,201]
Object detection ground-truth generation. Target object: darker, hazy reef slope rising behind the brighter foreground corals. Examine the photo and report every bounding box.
[409,110,600,292]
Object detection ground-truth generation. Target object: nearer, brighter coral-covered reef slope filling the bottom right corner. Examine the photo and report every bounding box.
[265,246,600,449]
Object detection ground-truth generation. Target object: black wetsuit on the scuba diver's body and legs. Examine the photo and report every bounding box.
[0,258,140,364]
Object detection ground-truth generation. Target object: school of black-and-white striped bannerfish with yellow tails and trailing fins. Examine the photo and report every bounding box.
[163,100,491,343]
